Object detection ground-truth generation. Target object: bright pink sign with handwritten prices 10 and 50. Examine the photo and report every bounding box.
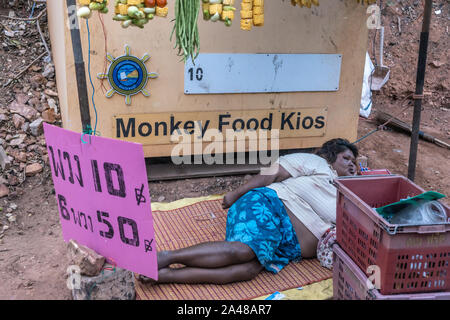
[44,123,158,280]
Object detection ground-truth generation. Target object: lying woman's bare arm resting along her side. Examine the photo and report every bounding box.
[222,164,291,209]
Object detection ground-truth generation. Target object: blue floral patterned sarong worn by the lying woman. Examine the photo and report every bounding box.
[225,187,301,273]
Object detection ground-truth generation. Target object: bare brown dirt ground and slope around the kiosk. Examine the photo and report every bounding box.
[0,0,450,300]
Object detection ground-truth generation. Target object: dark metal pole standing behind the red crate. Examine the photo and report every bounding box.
[408,0,433,181]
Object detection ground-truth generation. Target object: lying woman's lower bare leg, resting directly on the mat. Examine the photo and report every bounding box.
[157,259,264,284]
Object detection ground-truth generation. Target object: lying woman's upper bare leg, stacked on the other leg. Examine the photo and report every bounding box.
[158,241,256,269]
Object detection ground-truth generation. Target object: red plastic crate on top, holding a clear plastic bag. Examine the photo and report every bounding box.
[335,175,450,295]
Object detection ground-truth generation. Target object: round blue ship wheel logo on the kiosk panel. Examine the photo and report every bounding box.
[97,45,158,105]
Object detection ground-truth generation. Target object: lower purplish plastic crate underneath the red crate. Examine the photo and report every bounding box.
[333,245,450,300]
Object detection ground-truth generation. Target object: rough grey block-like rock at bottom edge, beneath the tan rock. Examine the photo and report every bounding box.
[68,263,136,300]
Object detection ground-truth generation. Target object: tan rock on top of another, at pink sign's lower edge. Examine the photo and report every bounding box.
[67,240,105,276]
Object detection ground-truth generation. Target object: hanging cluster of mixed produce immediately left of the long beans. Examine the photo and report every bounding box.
[113,0,169,28]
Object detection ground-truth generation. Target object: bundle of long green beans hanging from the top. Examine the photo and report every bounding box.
[170,0,200,63]
